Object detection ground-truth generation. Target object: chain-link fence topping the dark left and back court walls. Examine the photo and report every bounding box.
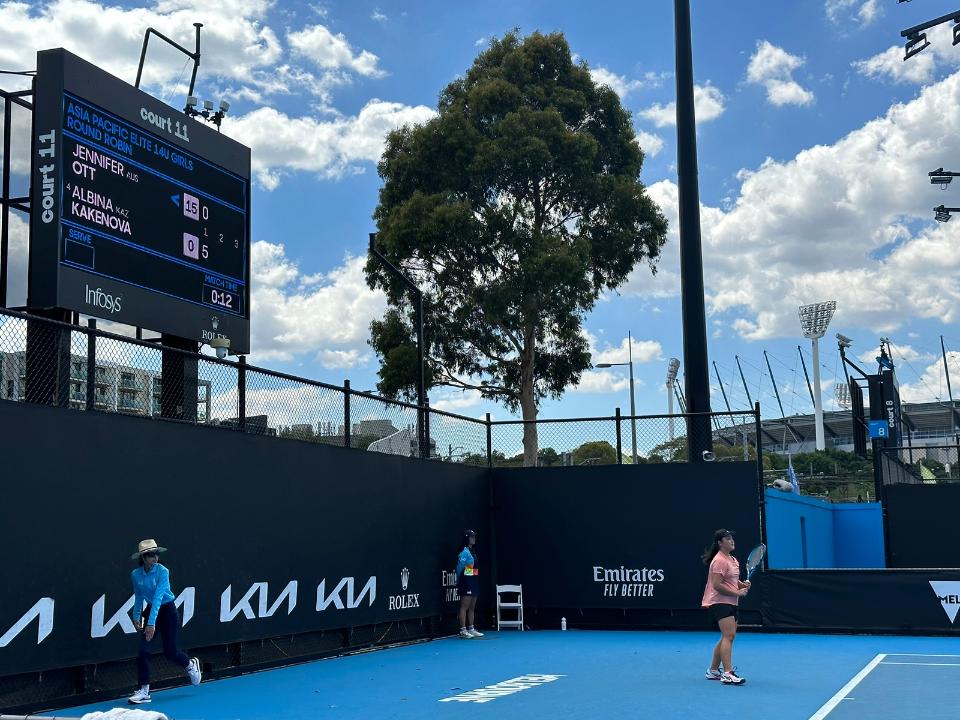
[0,310,758,467]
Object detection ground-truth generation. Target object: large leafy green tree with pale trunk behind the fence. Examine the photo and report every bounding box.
[366,32,667,464]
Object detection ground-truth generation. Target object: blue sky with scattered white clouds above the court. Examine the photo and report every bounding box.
[0,0,960,418]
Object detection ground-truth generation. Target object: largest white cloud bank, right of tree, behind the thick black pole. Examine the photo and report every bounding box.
[623,73,960,340]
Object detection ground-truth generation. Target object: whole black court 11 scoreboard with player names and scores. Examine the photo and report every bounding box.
[28,50,250,353]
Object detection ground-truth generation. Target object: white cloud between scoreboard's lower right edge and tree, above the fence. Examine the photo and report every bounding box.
[250,240,386,369]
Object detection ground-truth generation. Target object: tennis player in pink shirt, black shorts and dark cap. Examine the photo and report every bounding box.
[700,530,750,685]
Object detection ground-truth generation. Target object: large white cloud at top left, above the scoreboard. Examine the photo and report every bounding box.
[0,0,398,118]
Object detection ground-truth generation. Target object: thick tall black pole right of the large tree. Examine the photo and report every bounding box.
[673,0,713,462]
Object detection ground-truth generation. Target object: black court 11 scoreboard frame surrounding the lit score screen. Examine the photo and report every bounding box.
[27,48,251,354]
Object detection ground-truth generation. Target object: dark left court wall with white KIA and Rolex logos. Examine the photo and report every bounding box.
[0,403,489,676]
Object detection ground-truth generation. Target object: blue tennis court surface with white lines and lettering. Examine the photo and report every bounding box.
[57,630,960,720]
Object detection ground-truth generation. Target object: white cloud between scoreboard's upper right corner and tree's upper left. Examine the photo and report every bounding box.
[223,100,435,190]
